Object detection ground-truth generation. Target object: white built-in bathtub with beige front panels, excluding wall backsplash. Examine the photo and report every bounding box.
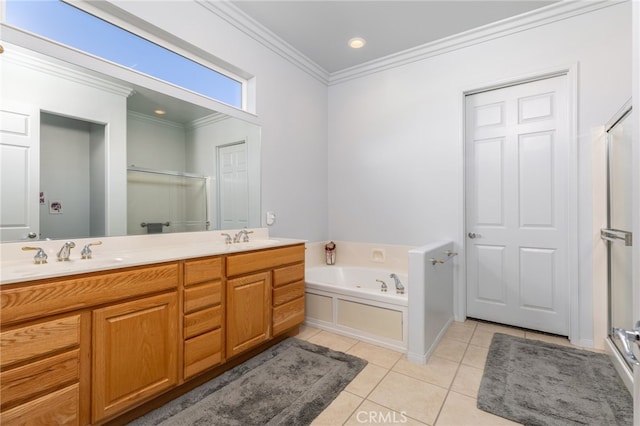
[305,265,408,352]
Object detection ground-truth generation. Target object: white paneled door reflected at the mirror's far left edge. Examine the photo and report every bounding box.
[0,99,40,241]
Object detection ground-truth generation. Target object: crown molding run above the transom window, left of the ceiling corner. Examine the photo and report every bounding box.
[195,0,330,84]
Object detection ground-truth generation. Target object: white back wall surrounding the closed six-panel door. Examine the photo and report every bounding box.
[328,3,631,344]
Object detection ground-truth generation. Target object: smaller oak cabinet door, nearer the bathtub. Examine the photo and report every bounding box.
[227,271,271,358]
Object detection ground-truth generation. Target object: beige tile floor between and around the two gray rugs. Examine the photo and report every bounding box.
[297,320,584,426]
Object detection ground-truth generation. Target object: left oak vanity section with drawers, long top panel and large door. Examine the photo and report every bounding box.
[0,262,179,425]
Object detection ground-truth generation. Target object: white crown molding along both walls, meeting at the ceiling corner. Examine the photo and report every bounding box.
[201,0,630,86]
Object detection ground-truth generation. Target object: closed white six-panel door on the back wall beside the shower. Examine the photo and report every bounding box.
[465,76,570,335]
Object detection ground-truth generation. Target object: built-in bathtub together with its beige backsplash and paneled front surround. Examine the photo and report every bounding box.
[305,241,412,352]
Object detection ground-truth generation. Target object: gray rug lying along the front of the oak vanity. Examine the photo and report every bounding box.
[130,338,367,426]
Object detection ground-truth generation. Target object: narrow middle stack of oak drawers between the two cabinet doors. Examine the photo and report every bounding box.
[183,257,225,379]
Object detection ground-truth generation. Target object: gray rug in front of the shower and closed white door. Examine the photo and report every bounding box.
[478,334,633,425]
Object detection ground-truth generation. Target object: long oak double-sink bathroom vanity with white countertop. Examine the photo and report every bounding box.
[0,233,305,425]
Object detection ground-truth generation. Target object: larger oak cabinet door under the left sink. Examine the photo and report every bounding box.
[92,292,178,422]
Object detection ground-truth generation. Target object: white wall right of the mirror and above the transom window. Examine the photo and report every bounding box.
[107,0,328,241]
